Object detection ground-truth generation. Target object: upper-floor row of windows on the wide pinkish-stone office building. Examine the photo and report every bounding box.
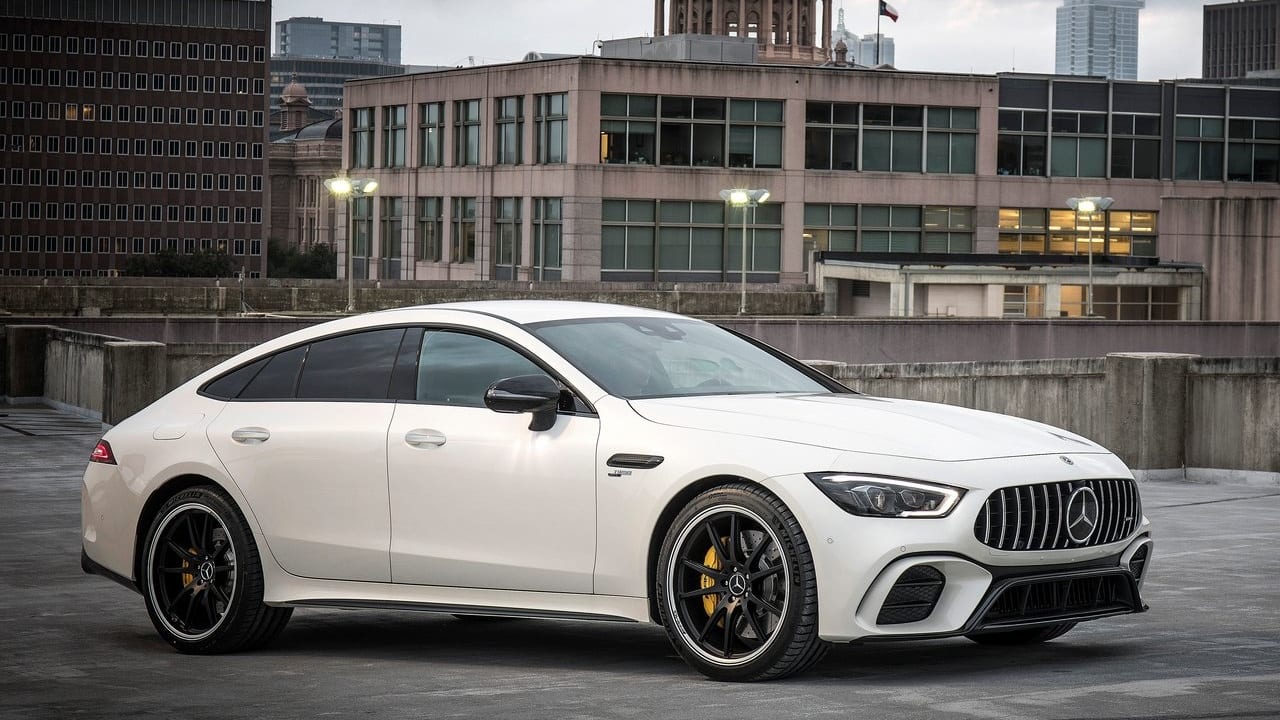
[351,94,1280,182]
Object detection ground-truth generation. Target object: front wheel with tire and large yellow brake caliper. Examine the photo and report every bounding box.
[654,484,828,682]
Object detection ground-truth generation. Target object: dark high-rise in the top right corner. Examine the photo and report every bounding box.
[1202,0,1280,78]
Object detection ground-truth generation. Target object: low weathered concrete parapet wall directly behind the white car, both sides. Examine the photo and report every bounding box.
[0,325,1280,474]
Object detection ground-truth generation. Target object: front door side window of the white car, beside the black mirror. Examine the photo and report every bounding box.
[417,331,544,407]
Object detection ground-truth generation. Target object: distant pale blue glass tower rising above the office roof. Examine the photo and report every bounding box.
[1056,0,1147,79]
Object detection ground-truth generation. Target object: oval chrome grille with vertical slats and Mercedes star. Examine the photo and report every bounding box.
[973,479,1142,551]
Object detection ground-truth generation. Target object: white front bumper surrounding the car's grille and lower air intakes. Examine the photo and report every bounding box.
[771,455,1152,642]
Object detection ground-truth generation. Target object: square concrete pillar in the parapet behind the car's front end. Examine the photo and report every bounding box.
[1105,352,1199,475]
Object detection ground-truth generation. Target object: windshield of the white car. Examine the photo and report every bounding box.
[529,318,831,400]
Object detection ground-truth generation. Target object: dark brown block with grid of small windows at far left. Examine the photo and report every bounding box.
[0,0,271,277]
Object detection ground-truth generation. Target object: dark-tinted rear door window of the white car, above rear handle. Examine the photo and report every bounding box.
[295,328,404,400]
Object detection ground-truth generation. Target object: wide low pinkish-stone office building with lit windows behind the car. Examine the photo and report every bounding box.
[337,47,1280,320]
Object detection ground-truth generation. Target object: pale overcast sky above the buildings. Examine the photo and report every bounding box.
[273,0,1203,79]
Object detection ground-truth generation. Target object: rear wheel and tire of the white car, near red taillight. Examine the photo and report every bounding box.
[138,486,293,655]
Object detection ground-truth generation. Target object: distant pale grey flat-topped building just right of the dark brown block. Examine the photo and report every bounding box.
[275,18,401,64]
